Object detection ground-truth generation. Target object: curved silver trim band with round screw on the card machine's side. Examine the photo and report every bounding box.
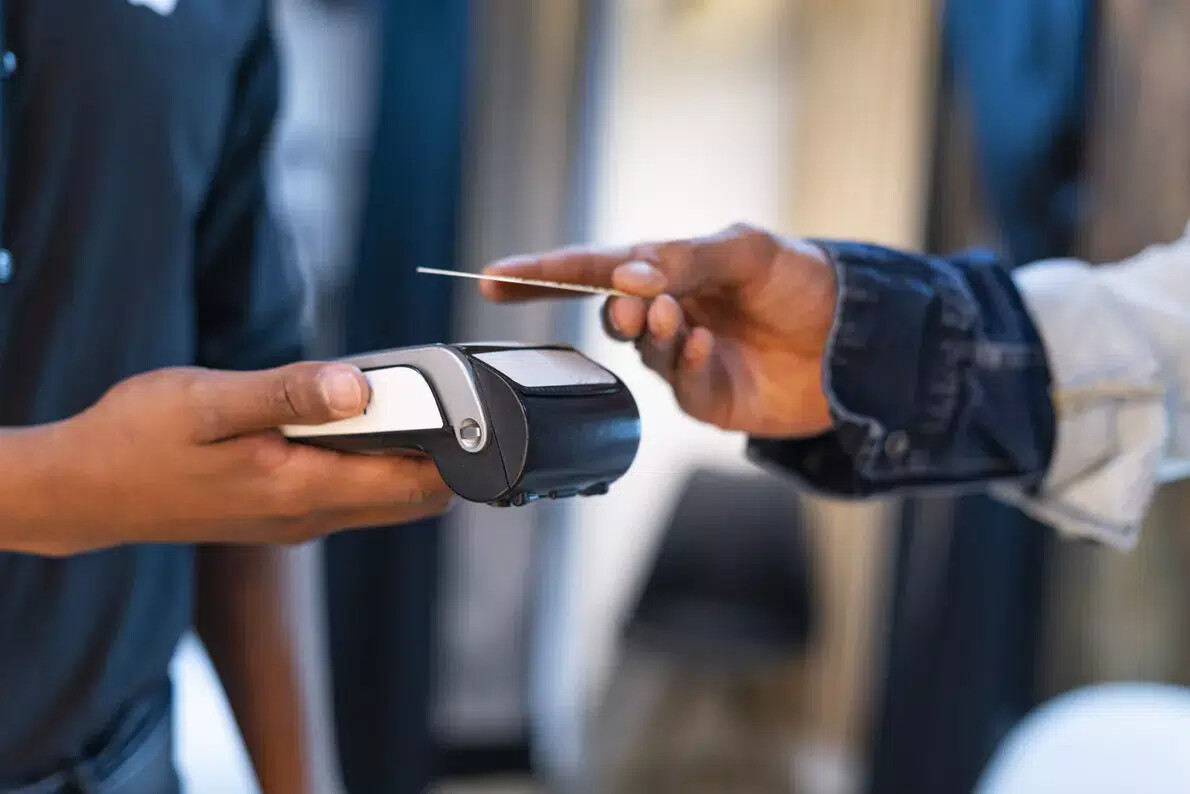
[340,344,491,452]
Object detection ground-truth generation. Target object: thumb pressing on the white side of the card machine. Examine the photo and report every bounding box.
[187,362,370,443]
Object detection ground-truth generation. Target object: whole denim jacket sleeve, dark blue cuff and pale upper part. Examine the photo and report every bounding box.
[750,229,1190,549]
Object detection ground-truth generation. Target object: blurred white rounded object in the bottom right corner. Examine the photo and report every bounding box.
[977,683,1190,794]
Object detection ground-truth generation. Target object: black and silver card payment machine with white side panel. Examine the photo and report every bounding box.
[283,344,640,506]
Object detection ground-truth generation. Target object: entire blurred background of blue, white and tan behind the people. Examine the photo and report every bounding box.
[175,0,1190,794]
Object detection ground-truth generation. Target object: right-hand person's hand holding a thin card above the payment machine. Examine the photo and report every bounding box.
[464,225,838,438]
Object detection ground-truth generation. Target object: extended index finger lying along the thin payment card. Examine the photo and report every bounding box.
[480,248,633,302]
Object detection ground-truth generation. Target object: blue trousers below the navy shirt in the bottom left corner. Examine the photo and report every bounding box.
[0,689,181,794]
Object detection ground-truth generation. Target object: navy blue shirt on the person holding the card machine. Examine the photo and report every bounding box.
[0,0,301,783]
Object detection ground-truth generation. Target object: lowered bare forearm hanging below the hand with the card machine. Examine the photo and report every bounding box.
[195,546,314,794]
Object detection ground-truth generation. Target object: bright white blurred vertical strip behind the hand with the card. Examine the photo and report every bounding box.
[571,0,790,733]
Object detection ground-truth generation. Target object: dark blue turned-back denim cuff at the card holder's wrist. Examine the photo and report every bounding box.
[749,240,1053,496]
